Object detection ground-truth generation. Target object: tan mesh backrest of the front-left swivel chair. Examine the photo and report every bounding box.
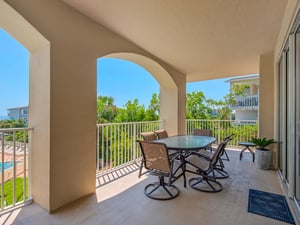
[139,141,171,174]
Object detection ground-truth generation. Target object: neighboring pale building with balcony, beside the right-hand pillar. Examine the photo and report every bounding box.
[226,74,259,120]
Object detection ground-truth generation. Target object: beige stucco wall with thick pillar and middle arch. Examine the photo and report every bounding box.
[7,0,186,212]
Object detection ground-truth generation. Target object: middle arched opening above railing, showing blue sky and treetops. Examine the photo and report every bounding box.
[97,57,159,123]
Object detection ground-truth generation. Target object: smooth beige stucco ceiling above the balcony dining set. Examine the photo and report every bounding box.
[63,0,287,81]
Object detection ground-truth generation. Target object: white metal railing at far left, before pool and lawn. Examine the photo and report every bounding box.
[0,128,33,212]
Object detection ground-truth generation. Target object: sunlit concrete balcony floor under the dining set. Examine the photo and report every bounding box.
[0,151,296,225]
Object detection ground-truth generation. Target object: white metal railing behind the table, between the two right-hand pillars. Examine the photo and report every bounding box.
[186,119,258,146]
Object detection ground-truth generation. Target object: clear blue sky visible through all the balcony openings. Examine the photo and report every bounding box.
[0,29,229,117]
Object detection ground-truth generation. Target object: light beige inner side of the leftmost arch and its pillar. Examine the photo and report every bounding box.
[0,1,50,210]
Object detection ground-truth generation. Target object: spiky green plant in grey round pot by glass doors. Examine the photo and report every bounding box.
[251,138,276,170]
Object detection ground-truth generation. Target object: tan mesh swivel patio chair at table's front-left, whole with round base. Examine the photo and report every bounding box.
[138,141,180,200]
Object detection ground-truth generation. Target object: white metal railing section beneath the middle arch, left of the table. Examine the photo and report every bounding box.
[96,121,163,172]
